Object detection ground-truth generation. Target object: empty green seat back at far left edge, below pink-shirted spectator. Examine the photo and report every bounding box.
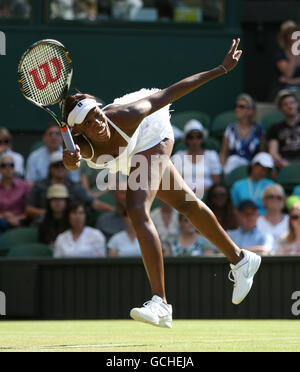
[0,227,38,256]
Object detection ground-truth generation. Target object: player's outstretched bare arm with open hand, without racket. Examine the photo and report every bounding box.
[135,39,243,116]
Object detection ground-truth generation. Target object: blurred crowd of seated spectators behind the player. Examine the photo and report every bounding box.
[0,81,300,258]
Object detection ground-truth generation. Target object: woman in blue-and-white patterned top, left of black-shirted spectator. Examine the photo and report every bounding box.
[220,93,265,174]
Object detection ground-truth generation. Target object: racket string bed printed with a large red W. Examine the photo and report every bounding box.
[20,44,72,105]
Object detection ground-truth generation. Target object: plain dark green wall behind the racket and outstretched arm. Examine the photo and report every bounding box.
[0,20,243,132]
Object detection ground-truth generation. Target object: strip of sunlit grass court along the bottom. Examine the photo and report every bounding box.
[0,320,300,352]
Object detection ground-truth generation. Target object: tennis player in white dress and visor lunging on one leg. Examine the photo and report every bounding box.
[64,39,261,328]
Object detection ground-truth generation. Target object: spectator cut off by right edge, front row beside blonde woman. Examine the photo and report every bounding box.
[276,203,300,255]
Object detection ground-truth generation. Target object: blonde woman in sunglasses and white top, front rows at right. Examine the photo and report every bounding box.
[257,184,289,250]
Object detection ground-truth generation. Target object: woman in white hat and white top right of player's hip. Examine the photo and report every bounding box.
[172,119,222,196]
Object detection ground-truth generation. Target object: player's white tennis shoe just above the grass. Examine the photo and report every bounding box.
[130,296,172,328]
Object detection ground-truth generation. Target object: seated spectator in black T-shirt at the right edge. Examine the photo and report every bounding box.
[267,90,300,168]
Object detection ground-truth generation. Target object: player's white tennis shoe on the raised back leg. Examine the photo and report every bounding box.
[228,249,261,305]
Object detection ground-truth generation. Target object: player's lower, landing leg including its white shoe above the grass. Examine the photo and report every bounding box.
[126,141,172,328]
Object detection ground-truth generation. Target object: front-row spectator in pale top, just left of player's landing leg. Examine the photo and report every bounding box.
[107,211,142,257]
